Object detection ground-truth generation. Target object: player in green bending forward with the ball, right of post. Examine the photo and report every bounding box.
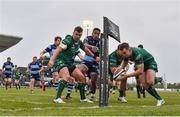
[119,43,165,106]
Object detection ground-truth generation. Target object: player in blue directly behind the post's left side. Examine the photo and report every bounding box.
[83,28,101,100]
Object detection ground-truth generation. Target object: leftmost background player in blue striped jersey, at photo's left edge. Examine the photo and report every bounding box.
[2,57,14,90]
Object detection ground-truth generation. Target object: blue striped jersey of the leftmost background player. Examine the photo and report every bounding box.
[3,62,14,75]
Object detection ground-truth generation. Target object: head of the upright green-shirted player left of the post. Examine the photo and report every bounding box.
[73,26,83,40]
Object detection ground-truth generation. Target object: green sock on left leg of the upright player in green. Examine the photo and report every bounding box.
[56,80,67,99]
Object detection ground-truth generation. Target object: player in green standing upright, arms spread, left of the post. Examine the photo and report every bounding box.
[48,26,100,103]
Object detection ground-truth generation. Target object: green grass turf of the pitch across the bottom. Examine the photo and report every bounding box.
[0,88,180,116]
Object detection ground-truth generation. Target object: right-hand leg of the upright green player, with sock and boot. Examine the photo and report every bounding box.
[72,68,92,103]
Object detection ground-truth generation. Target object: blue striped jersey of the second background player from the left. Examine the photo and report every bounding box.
[28,62,42,75]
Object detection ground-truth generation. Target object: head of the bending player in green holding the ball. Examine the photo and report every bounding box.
[118,43,132,57]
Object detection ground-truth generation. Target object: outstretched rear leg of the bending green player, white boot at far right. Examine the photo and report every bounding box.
[145,69,165,106]
